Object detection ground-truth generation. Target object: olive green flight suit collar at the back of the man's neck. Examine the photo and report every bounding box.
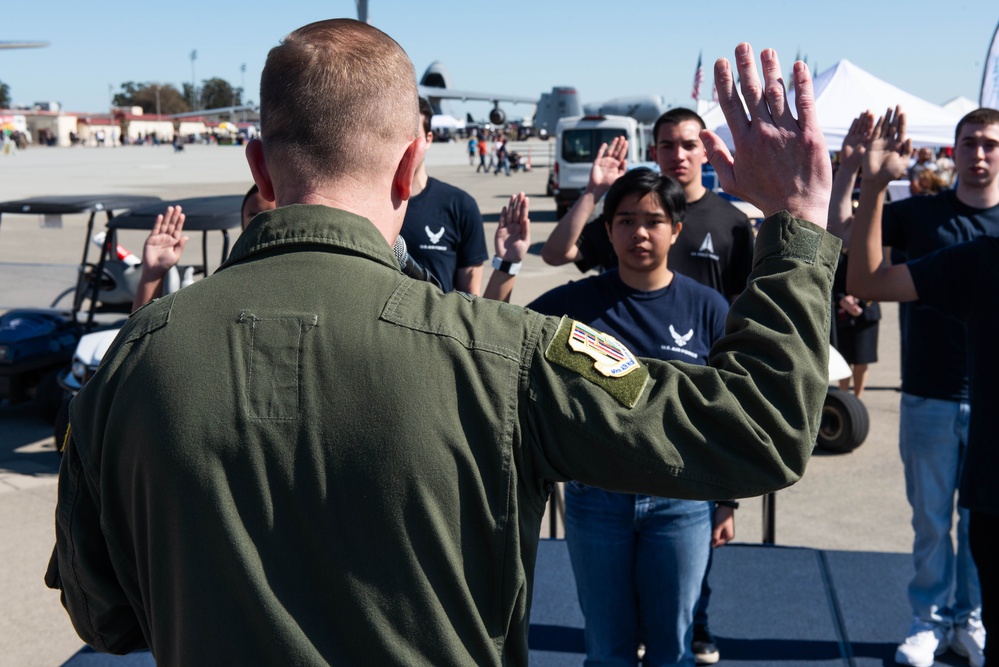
[221,204,399,269]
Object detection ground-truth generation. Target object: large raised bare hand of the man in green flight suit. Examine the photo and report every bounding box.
[701,43,832,227]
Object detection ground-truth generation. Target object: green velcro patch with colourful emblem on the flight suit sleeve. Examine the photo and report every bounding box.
[545,317,649,409]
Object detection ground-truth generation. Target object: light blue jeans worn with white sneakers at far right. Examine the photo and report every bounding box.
[899,393,982,625]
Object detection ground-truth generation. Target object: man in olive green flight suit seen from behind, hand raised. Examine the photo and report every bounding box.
[46,20,839,665]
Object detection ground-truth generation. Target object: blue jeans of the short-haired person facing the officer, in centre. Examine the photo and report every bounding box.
[565,482,711,667]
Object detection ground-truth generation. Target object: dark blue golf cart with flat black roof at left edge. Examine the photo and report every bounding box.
[0,195,160,421]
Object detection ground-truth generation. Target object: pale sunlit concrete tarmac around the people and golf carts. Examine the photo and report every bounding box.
[0,140,912,666]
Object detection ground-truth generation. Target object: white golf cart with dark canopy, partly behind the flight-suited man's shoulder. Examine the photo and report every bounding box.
[55,195,243,443]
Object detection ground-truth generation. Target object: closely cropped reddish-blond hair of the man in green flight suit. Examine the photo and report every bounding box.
[260,19,419,182]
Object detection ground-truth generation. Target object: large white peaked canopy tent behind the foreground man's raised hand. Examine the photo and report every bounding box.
[708,59,963,151]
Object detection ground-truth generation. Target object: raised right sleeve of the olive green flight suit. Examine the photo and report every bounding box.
[522,212,840,499]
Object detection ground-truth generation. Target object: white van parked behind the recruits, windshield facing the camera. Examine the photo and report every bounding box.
[552,115,651,219]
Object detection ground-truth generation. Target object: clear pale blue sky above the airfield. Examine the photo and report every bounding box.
[0,0,999,117]
